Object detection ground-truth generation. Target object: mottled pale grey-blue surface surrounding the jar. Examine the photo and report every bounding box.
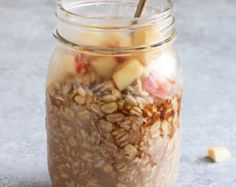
[0,0,236,187]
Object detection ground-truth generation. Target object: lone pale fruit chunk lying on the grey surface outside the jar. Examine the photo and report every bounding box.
[208,147,231,162]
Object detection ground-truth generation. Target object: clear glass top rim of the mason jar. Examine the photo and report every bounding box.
[56,0,173,29]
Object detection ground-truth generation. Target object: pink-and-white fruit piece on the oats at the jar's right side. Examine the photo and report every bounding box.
[143,73,175,99]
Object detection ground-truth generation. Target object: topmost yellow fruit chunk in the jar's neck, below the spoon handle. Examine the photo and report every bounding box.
[133,26,160,46]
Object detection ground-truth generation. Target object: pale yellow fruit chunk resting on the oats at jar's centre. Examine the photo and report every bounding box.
[113,59,143,90]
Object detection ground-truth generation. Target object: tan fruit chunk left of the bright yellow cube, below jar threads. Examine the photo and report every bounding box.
[91,57,117,78]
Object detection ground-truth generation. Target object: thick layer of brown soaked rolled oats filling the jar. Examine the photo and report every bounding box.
[46,72,183,187]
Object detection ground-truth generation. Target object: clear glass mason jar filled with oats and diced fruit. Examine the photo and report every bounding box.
[46,0,182,187]
